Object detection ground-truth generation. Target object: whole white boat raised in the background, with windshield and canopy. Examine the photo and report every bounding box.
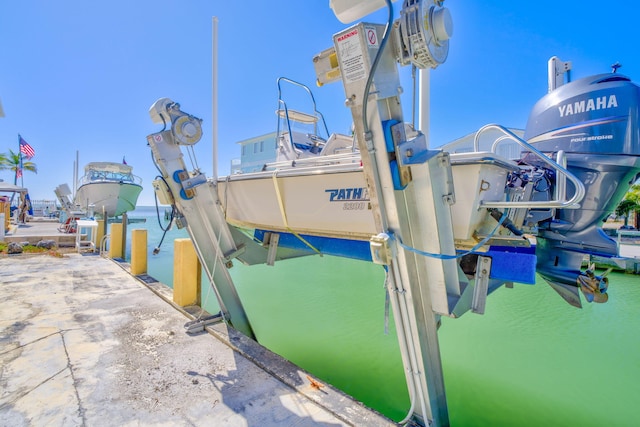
[74,162,142,218]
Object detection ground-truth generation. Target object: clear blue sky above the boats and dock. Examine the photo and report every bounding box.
[0,0,640,205]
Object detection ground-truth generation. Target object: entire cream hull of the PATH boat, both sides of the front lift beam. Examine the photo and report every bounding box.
[218,153,513,252]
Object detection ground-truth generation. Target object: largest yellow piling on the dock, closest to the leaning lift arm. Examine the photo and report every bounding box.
[173,239,202,307]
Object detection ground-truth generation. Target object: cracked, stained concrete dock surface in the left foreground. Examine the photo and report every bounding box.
[0,253,396,426]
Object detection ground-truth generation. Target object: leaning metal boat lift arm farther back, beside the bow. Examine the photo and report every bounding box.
[147,118,255,339]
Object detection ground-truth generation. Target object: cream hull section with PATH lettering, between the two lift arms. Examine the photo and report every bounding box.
[218,167,375,241]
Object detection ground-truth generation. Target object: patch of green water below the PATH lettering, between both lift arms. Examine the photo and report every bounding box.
[232,256,409,418]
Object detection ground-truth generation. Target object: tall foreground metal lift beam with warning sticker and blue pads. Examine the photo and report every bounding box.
[334,23,460,426]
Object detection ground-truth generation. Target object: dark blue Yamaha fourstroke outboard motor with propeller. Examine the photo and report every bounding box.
[524,57,640,307]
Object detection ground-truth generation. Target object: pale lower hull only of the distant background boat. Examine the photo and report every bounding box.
[75,182,142,218]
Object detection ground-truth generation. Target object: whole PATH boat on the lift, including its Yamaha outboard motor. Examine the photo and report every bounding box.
[217,57,640,307]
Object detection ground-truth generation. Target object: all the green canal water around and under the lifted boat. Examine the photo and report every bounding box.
[129,207,640,426]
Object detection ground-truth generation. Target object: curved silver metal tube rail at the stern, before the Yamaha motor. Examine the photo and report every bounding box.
[473,124,585,209]
